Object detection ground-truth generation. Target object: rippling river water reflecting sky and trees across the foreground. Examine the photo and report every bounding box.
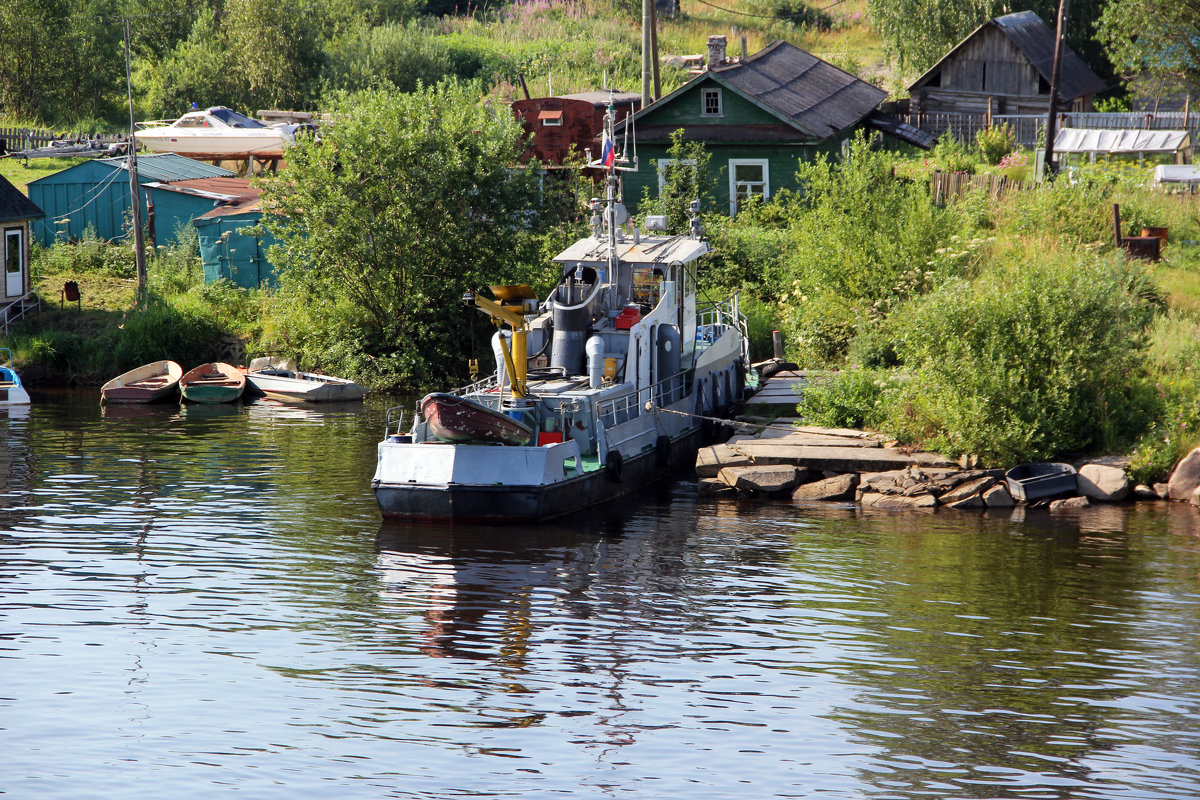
[0,392,1200,800]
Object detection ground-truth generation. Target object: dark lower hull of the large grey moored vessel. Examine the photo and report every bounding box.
[372,431,701,524]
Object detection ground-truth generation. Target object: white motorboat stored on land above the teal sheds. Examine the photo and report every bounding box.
[133,106,305,160]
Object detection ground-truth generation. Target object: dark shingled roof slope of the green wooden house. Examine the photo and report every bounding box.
[706,40,888,139]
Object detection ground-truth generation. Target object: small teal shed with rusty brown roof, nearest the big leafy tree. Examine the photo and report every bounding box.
[192,197,277,289]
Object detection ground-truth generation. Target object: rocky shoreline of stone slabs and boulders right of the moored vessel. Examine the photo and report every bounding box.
[696,419,1200,511]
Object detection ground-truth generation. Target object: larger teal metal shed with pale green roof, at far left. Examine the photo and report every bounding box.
[29,152,234,247]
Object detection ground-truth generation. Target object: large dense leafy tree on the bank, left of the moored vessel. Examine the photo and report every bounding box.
[264,82,549,389]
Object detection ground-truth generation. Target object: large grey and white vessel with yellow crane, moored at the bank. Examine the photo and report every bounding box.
[371,104,749,523]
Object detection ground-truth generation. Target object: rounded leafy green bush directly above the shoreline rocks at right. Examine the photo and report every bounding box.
[888,248,1154,464]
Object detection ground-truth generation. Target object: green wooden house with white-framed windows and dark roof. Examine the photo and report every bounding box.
[617,36,934,215]
